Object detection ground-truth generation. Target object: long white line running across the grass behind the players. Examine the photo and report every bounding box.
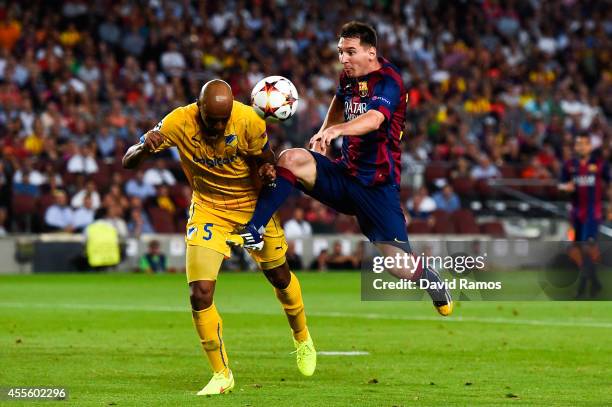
[0,302,612,329]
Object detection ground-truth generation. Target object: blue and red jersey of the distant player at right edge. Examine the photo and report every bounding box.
[561,156,610,222]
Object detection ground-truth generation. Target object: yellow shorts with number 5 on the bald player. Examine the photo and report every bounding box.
[185,202,287,264]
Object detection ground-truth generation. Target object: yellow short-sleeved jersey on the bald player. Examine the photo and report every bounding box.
[149,101,268,211]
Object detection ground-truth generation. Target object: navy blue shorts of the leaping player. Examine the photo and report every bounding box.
[297,151,408,242]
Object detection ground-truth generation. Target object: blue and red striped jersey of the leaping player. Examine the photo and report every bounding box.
[336,58,406,187]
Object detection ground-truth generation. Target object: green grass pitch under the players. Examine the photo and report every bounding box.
[0,273,612,406]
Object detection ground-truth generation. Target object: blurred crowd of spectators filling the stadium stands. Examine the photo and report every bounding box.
[0,0,612,236]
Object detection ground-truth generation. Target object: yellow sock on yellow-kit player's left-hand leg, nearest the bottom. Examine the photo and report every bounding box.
[192,304,229,376]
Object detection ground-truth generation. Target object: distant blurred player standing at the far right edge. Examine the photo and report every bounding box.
[559,134,610,298]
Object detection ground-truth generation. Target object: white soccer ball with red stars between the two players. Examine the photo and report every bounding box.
[251,75,298,122]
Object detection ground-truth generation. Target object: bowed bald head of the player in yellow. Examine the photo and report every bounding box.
[198,79,234,139]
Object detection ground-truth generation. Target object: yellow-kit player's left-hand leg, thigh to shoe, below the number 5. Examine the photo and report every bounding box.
[187,245,234,396]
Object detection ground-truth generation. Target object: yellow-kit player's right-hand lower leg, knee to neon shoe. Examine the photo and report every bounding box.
[262,258,317,376]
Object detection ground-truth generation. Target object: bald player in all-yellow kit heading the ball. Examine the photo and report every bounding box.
[123,79,316,395]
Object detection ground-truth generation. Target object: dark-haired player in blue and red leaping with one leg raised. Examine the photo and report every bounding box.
[228,21,453,315]
